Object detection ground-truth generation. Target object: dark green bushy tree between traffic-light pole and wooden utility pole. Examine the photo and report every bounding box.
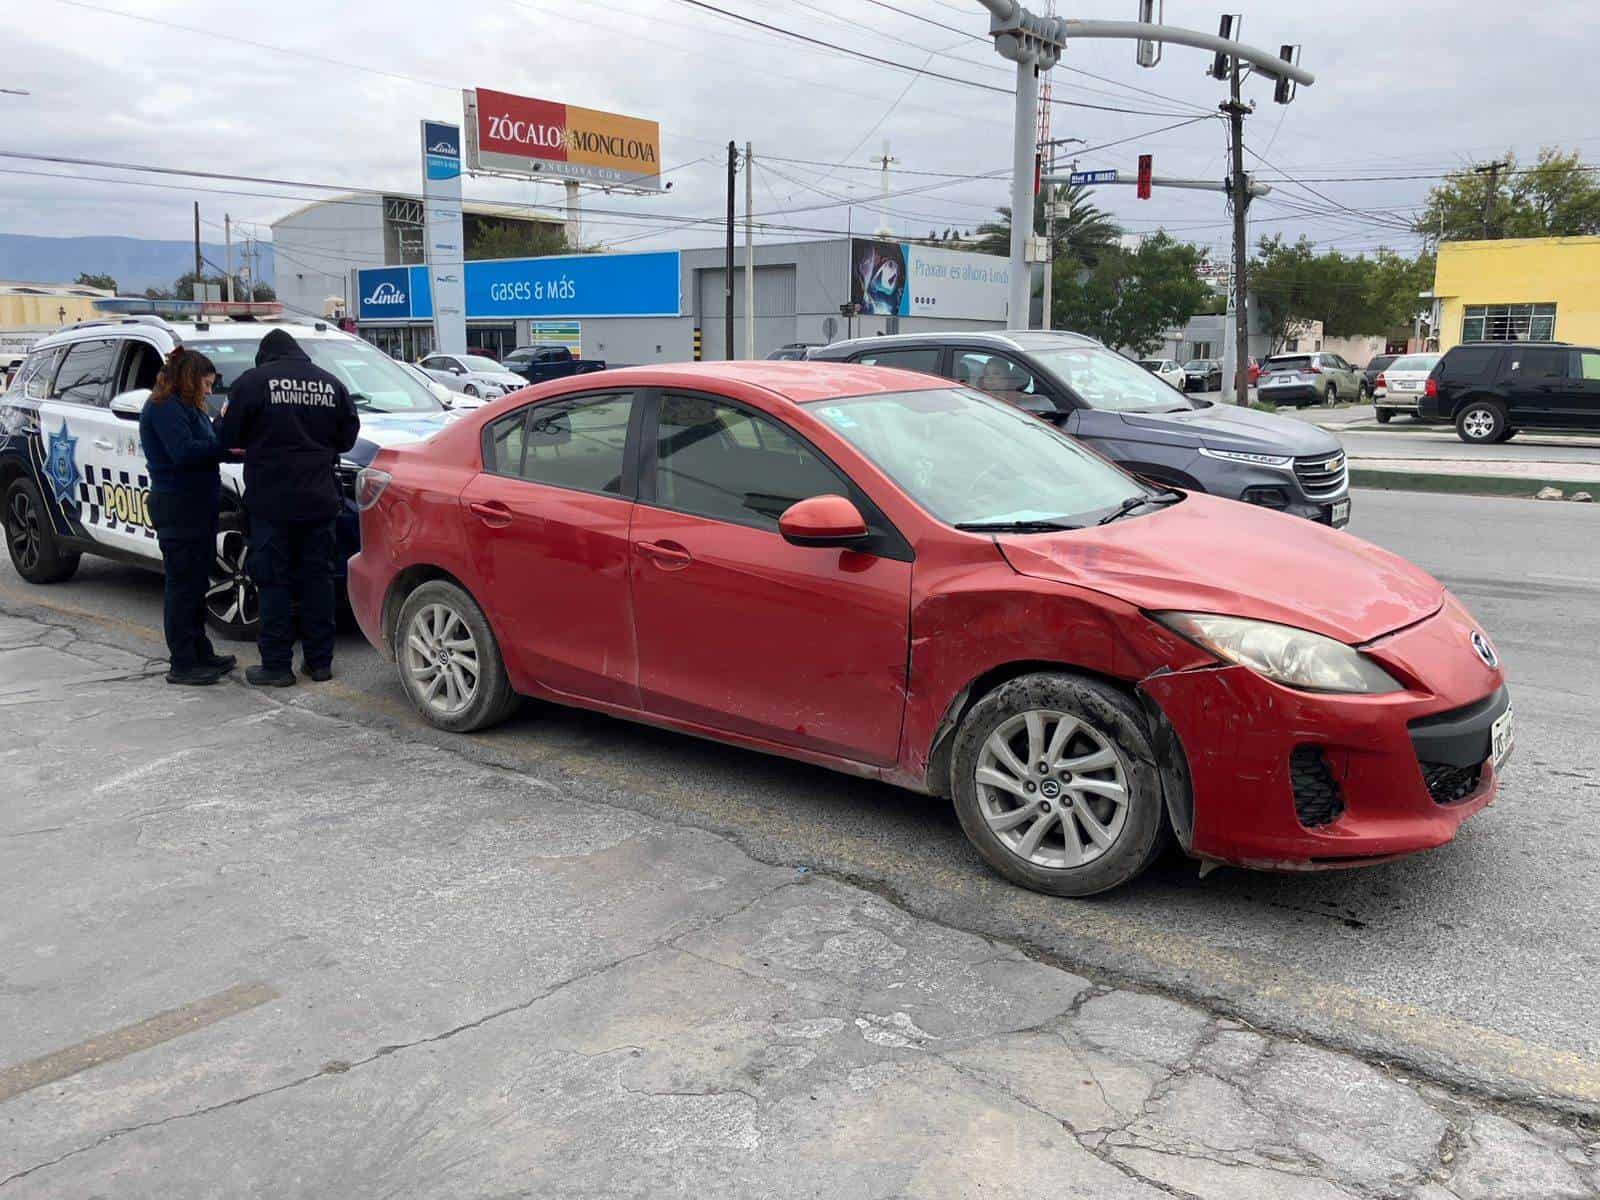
[1051,234,1210,354]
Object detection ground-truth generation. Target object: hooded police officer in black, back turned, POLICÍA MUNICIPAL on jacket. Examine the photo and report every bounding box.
[221,330,362,688]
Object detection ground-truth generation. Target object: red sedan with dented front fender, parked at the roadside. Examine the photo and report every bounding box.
[349,363,1510,896]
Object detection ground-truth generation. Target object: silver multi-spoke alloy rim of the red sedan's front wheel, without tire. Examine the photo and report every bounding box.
[976,709,1130,870]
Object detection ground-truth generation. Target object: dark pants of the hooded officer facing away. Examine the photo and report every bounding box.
[248,515,338,670]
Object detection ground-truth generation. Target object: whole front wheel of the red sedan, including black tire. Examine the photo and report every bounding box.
[950,674,1166,896]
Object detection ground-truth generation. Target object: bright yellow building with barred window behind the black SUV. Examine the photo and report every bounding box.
[1434,237,1600,350]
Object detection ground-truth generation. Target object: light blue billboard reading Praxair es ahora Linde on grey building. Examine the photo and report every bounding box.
[850,237,1011,322]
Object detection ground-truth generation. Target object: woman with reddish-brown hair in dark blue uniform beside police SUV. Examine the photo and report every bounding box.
[139,346,237,686]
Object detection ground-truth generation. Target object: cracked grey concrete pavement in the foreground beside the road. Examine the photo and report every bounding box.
[0,614,1600,1200]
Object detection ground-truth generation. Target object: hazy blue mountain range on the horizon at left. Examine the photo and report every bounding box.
[0,234,274,294]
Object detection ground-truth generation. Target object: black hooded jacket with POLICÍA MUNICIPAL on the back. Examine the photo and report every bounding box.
[221,330,362,522]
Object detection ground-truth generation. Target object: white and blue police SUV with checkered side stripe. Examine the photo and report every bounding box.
[0,299,451,640]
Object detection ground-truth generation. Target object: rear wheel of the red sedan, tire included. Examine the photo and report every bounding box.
[394,579,517,733]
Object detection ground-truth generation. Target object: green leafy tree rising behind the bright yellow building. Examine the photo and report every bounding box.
[1416,147,1600,243]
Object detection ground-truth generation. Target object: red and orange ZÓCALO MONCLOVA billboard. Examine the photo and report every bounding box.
[464,88,661,192]
